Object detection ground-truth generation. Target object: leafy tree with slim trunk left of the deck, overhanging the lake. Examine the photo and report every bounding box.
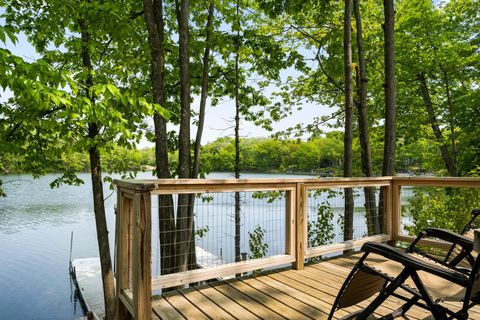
[5,1,166,319]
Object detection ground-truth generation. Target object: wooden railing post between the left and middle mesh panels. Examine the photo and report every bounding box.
[292,183,308,270]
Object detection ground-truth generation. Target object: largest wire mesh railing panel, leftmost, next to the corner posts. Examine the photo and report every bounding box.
[152,191,287,277]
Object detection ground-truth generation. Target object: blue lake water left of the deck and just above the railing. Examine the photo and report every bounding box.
[0,173,316,320]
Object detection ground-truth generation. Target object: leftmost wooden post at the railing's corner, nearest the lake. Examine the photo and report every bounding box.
[115,188,133,320]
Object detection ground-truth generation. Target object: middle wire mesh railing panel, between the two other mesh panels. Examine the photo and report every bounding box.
[307,187,384,249]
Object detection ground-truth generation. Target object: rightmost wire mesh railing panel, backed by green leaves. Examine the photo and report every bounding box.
[400,186,480,236]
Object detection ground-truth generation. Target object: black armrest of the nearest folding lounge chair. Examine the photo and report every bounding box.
[362,242,469,287]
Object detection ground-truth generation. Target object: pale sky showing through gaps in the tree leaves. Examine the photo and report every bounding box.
[0,20,332,148]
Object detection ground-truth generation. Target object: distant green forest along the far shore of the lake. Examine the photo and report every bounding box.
[3,131,448,176]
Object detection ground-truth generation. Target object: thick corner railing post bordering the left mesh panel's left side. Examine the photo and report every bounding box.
[132,191,152,320]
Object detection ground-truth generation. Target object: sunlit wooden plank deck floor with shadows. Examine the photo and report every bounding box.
[152,253,480,319]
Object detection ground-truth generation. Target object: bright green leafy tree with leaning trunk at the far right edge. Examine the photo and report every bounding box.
[396,0,480,176]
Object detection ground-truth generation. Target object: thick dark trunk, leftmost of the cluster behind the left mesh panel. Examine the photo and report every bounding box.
[143,0,179,274]
